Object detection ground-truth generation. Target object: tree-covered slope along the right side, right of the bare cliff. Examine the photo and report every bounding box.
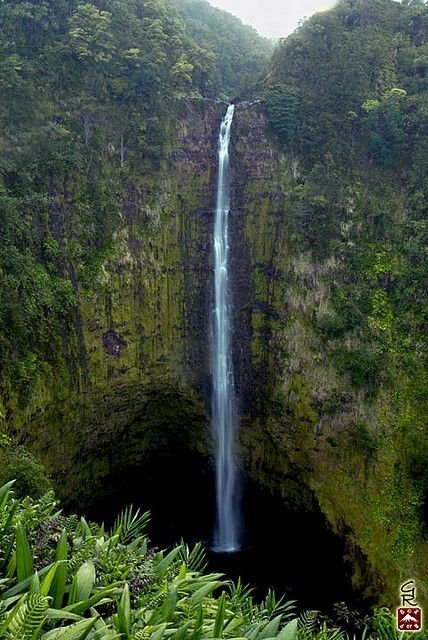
[265,0,428,597]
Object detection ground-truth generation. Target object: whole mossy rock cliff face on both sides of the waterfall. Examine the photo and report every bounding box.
[4,101,427,603]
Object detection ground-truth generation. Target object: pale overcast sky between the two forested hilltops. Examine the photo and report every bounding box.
[208,0,334,38]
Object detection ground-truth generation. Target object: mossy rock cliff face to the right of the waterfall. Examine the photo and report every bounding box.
[232,105,428,606]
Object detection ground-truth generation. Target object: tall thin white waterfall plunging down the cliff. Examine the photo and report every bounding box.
[211,105,239,553]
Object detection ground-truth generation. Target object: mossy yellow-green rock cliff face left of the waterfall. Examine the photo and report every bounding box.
[4,101,225,505]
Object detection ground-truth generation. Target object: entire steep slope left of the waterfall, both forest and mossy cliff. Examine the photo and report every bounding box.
[0,0,238,516]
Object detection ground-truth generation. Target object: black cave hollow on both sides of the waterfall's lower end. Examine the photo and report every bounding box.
[79,441,363,612]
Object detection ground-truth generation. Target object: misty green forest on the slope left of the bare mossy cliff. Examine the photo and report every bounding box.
[0,0,269,392]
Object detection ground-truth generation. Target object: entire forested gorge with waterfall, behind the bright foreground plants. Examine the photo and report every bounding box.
[0,0,428,628]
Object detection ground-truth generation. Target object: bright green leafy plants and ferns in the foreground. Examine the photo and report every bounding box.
[0,483,422,640]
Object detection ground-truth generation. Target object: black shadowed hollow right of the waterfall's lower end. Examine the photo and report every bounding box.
[209,479,358,613]
